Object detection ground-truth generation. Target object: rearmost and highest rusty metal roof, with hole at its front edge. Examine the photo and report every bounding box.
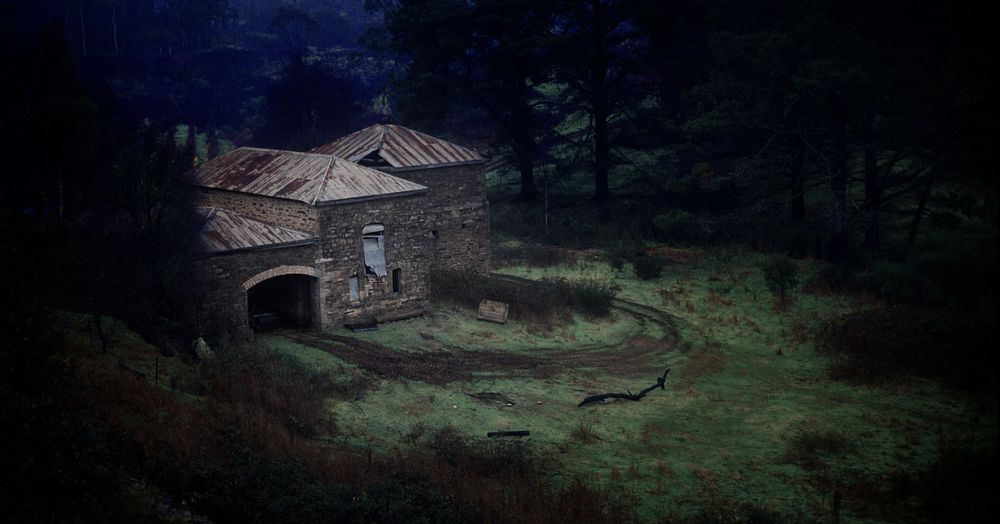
[311,124,486,171]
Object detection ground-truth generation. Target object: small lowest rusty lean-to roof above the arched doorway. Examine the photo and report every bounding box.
[198,207,316,254]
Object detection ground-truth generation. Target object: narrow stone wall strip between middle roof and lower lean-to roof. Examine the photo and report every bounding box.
[195,187,319,233]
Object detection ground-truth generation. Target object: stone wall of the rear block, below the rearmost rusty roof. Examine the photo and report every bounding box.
[390,164,490,273]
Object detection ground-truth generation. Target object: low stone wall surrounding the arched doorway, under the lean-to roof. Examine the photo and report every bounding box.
[196,245,321,340]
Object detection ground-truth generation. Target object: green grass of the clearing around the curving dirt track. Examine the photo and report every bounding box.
[266,251,997,521]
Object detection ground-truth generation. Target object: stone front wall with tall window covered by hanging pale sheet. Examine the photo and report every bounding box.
[316,194,432,326]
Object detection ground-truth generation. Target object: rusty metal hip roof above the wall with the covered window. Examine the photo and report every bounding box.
[193,147,427,204]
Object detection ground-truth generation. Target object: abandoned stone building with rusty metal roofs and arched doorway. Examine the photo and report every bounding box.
[192,126,489,338]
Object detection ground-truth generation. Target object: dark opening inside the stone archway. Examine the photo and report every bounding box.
[247,275,316,331]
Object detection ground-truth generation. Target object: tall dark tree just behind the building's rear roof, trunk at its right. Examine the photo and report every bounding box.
[386,0,553,200]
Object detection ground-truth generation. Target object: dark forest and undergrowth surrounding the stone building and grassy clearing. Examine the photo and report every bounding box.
[0,0,998,521]
